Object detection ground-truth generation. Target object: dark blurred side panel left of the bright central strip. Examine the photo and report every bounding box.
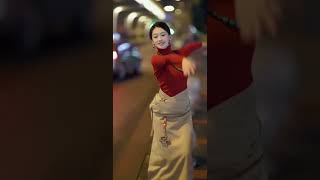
[0,0,112,180]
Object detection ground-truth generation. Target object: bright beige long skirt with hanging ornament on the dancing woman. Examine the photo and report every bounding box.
[148,90,195,180]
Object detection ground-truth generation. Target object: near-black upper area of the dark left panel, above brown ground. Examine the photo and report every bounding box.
[0,0,106,58]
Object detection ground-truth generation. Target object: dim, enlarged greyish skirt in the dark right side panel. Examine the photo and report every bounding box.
[207,86,267,180]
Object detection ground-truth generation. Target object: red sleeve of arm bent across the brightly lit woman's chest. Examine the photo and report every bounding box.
[151,53,183,70]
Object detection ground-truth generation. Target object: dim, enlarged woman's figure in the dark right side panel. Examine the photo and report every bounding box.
[207,0,267,180]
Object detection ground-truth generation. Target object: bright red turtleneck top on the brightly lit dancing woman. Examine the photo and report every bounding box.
[151,43,202,97]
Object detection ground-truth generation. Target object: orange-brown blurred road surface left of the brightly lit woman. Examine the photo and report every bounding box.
[113,43,158,180]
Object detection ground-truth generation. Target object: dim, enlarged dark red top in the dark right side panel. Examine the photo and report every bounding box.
[207,0,254,109]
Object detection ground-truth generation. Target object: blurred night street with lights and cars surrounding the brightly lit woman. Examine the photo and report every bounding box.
[113,0,207,180]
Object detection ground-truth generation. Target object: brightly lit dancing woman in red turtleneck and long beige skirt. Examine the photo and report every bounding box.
[148,22,202,180]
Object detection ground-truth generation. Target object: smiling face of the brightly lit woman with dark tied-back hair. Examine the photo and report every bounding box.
[152,27,171,49]
